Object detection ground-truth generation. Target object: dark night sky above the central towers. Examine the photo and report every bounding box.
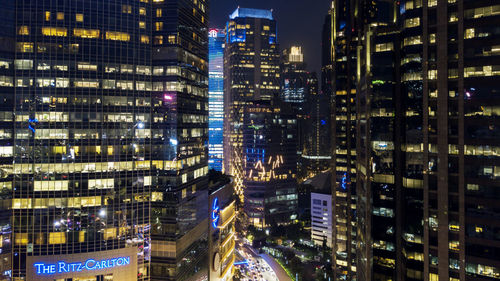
[210,0,331,74]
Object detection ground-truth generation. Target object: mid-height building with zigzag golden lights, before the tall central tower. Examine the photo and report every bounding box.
[242,97,298,228]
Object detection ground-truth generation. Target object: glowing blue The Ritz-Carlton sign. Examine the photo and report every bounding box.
[33,257,130,275]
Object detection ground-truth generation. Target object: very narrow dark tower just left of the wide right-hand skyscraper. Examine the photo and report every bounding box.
[328,0,357,280]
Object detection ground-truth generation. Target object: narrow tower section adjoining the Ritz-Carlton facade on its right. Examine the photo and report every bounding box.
[150,0,209,280]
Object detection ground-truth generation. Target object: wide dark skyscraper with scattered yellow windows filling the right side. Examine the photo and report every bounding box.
[334,0,500,281]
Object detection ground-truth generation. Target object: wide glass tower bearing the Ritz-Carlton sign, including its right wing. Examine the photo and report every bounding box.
[0,0,208,280]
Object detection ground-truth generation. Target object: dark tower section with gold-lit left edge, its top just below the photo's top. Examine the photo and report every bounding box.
[356,20,402,280]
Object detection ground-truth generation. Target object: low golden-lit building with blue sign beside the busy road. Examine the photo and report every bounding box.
[208,172,236,281]
